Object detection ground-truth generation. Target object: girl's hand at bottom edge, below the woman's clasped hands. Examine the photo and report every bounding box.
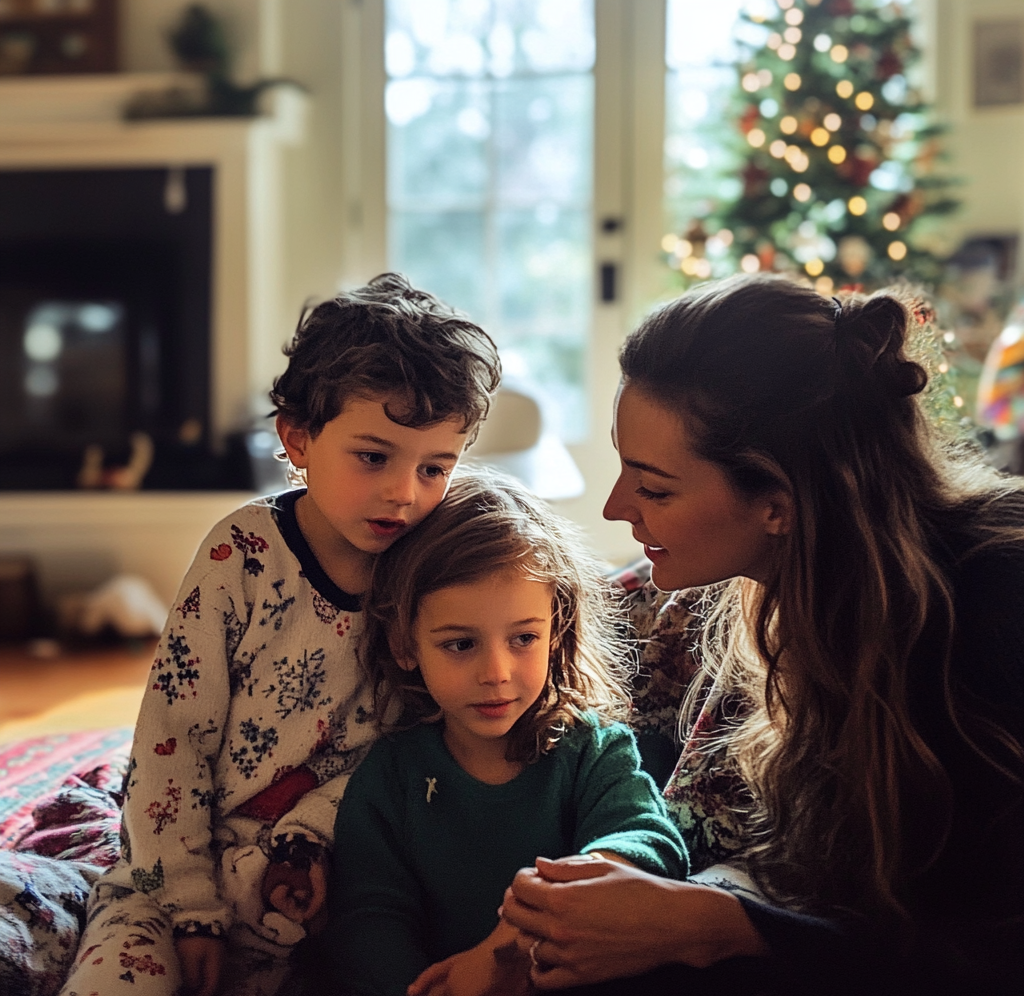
[408,920,534,996]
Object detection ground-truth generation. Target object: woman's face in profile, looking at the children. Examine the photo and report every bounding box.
[604,383,790,591]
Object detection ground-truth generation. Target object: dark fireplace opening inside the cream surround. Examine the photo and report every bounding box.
[0,168,252,490]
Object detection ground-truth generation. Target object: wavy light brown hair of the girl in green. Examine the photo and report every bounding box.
[362,469,633,764]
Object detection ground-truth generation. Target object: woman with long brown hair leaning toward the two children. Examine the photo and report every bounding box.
[504,275,1024,993]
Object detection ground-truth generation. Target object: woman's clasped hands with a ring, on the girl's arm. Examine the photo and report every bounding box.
[502,857,768,989]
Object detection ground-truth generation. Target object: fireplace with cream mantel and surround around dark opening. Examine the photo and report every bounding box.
[0,74,305,492]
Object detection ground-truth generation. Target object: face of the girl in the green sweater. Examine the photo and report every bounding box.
[402,568,553,774]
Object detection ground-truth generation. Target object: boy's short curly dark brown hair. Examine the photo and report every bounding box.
[270,273,501,441]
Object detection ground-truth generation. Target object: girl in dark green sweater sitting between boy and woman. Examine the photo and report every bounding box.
[328,472,686,996]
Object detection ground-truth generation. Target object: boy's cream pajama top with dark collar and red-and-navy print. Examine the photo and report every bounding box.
[103,490,374,944]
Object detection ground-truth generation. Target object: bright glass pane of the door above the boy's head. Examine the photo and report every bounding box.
[385,0,594,439]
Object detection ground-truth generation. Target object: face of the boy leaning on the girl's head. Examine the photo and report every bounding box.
[278,397,467,559]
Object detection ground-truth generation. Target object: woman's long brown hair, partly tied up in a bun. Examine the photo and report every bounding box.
[622,275,1024,922]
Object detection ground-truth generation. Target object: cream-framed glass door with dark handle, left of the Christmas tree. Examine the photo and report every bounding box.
[344,0,669,563]
